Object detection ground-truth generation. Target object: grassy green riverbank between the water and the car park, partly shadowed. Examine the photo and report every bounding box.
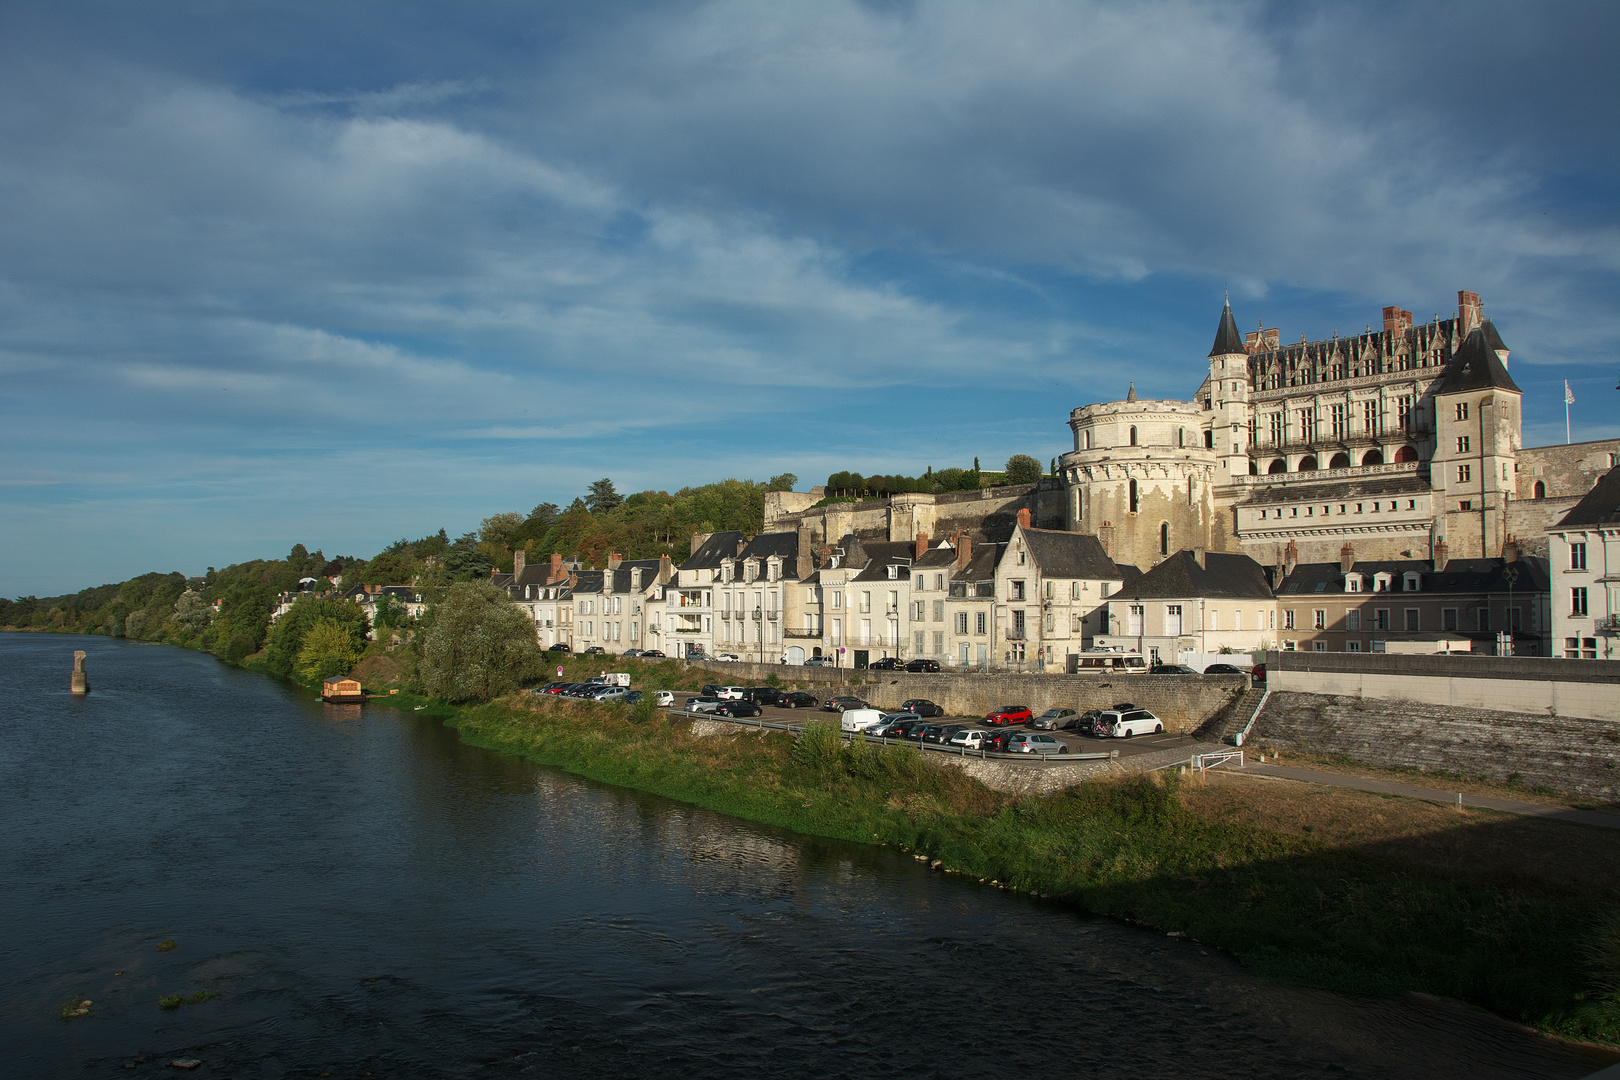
[367,696,1620,1046]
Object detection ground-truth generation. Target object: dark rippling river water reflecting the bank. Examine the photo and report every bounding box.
[0,633,1602,1080]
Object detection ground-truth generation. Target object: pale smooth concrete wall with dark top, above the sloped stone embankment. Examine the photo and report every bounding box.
[1267,653,1620,722]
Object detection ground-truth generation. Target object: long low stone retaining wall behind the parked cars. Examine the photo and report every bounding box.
[677,664,1247,733]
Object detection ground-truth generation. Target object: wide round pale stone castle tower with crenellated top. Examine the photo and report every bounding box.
[1058,385,1225,570]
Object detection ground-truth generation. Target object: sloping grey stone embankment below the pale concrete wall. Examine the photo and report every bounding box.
[1246,691,1620,798]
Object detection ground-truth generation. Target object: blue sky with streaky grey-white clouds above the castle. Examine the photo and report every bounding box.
[0,0,1620,596]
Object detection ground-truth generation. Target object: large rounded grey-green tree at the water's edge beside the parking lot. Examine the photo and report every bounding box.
[420,581,544,701]
